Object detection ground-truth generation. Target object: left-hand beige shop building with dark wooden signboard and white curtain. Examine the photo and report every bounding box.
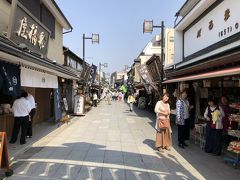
[0,0,80,136]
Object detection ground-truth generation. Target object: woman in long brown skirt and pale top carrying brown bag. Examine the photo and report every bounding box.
[154,93,172,152]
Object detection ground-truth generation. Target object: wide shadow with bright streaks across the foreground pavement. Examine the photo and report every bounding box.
[8,140,202,180]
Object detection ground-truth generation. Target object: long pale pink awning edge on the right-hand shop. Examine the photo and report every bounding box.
[163,67,240,84]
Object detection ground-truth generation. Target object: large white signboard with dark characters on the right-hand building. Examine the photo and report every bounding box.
[183,0,240,60]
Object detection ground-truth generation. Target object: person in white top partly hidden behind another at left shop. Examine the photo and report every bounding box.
[26,93,36,138]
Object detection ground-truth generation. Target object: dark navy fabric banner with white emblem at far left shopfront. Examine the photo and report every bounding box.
[0,61,20,96]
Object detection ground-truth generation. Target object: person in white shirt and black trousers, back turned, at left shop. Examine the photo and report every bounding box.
[9,92,31,144]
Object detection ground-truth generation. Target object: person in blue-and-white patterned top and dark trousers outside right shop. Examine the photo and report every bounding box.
[176,90,193,148]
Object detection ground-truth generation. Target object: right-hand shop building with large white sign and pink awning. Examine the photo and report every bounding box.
[164,0,240,139]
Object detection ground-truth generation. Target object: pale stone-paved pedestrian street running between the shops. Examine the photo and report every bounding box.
[8,101,240,180]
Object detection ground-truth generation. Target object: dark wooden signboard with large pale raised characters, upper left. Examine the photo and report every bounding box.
[10,2,50,55]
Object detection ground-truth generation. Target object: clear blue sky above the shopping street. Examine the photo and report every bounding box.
[56,0,185,73]
